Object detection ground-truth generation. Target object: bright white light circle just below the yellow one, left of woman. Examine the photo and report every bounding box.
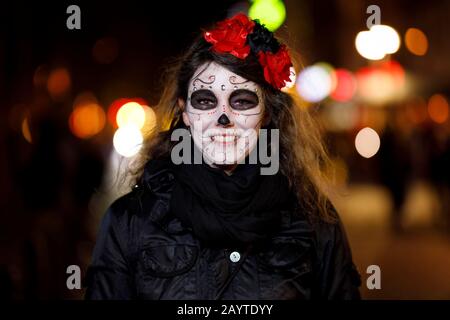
[113,125,144,158]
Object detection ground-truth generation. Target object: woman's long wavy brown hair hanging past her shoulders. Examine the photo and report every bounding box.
[131,35,335,221]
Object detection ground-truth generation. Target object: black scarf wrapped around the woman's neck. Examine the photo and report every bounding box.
[170,145,289,246]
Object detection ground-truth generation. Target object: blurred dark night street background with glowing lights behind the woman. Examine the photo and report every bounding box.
[0,0,450,299]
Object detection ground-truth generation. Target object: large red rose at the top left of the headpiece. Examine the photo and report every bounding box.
[204,13,255,59]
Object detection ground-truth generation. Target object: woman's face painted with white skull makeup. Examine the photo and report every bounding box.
[183,62,263,165]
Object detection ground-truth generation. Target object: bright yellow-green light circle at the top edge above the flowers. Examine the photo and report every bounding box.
[248,0,286,31]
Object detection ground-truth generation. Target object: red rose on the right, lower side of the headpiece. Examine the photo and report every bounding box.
[258,45,292,89]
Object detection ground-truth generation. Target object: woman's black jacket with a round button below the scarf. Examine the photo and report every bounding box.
[85,162,361,300]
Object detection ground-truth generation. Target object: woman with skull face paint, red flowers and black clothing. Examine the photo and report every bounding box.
[86,14,360,299]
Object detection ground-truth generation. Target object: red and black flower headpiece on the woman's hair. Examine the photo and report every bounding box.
[203,13,292,90]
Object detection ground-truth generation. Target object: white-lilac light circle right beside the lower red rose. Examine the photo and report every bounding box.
[296,63,335,103]
